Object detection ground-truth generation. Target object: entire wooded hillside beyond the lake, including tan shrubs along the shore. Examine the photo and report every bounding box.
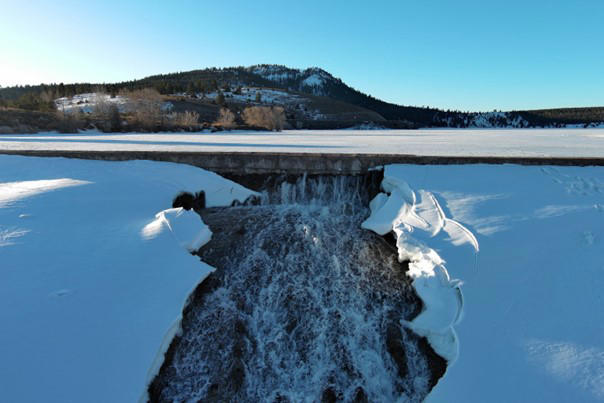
[0,65,604,132]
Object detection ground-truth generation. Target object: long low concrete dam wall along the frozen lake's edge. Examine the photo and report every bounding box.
[0,150,604,175]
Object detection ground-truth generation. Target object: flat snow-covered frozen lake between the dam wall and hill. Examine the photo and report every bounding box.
[0,129,604,158]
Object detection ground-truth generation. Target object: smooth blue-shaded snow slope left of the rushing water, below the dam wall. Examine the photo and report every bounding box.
[0,156,251,402]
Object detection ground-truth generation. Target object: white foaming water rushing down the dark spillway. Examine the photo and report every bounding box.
[150,177,432,402]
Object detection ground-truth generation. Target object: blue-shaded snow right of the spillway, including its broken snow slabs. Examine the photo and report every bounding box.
[364,165,604,402]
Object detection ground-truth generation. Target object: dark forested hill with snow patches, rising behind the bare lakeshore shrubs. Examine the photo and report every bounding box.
[0,65,604,129]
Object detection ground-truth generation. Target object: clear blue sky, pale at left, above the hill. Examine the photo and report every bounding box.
[0,0,604,110]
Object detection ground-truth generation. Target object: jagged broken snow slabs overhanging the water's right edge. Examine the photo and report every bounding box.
[361,166,478,363]
